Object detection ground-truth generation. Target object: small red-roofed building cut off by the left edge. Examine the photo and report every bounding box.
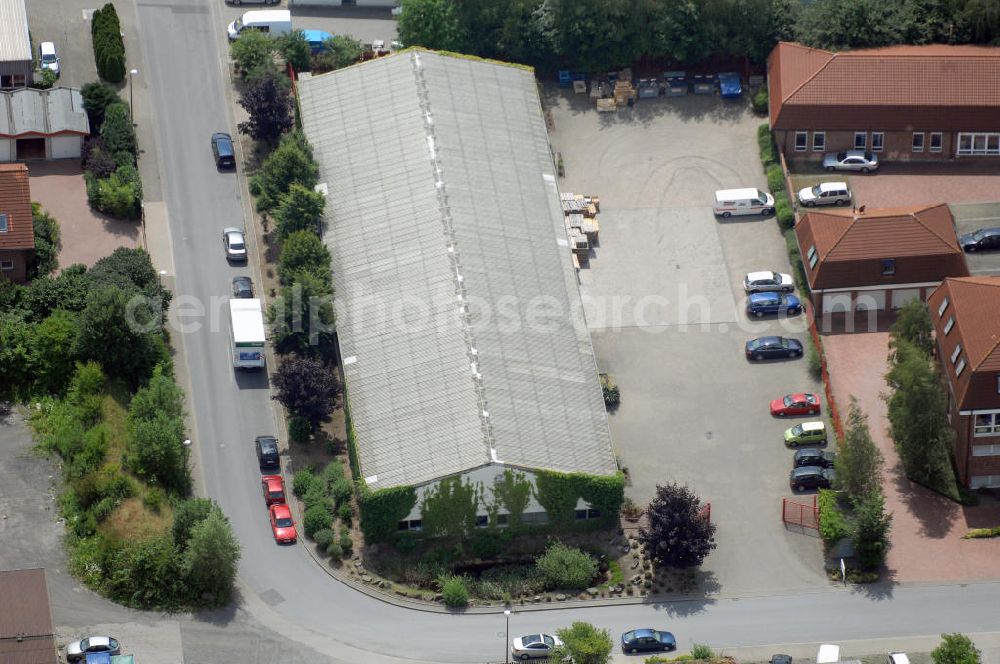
[0,164,35,283]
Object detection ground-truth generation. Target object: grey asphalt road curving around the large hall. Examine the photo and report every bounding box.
[127,0,1000,662]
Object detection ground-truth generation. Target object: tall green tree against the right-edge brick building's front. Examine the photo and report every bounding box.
[886,339,957,498]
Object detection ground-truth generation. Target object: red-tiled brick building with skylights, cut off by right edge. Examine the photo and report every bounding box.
[927,277,1000,489]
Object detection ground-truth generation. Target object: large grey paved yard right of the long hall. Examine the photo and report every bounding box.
[546,90,826,594]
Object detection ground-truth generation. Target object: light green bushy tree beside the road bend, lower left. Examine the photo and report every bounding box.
[180,507,240,606]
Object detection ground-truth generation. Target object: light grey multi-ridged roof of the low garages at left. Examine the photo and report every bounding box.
[0,88,90,136]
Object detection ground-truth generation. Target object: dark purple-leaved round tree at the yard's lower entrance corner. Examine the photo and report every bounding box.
[639,482,716,569]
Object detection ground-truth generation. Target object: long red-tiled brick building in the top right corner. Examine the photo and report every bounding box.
[768,42,1000,161]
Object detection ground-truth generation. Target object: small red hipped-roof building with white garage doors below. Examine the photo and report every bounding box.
[795,203,969,317]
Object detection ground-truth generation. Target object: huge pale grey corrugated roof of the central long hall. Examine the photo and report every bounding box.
[299,50,615,487]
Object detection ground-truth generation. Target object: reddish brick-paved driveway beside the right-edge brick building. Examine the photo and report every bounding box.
[823,331,1000,583]
